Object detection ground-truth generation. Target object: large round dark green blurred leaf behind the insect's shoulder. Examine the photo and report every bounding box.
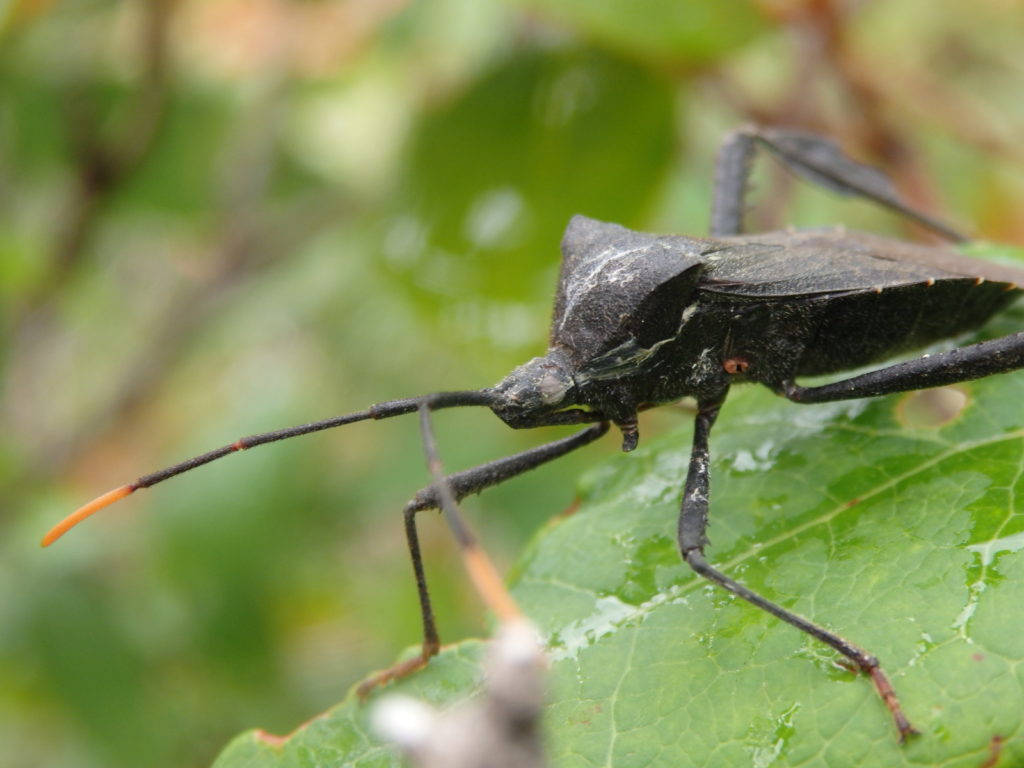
[390,45,675,307]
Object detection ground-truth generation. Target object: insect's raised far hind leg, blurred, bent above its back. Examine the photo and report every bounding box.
[711,126,967,242]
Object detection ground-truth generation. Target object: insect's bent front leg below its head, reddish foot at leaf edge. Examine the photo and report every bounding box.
[357,422,608,696]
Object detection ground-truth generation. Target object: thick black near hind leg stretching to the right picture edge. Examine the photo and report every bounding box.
[776,333,1024,403]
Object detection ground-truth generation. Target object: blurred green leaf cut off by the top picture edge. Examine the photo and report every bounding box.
[518,0,765,63]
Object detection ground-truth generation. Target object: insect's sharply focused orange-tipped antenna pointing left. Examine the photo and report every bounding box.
[42,389,496,547]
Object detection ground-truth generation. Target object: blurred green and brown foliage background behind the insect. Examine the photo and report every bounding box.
[0,0,1024,768]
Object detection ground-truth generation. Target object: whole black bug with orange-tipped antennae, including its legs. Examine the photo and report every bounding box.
[43,128,1024,738]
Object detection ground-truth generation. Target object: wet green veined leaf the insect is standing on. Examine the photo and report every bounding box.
[216,286,1024,768]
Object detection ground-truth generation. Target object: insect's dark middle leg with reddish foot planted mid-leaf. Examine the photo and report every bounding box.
[678,400,916,740]
